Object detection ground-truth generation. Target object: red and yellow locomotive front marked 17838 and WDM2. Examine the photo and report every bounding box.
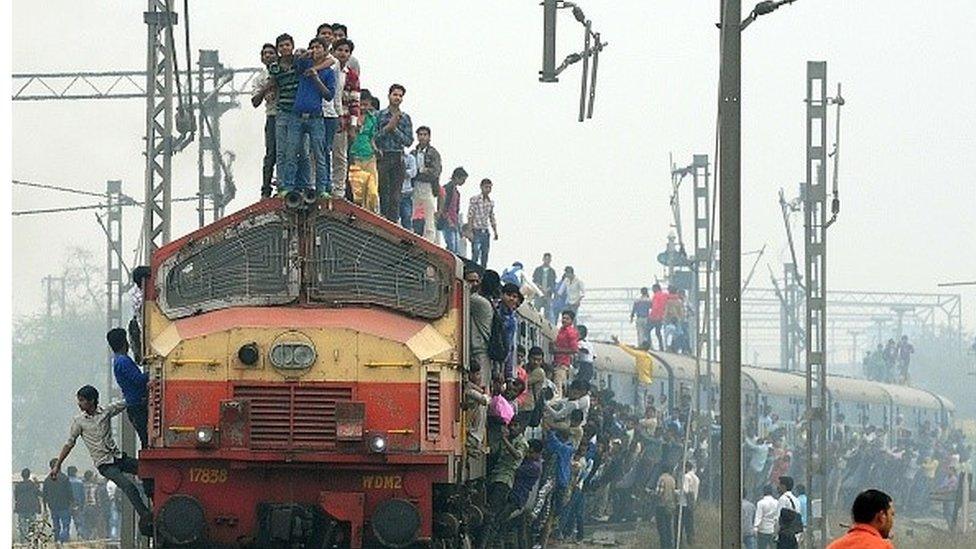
[140,199,465,548]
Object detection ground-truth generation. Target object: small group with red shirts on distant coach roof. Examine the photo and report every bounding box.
[630,284,695,354]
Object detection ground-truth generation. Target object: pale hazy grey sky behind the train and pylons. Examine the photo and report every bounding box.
[12,0,976,327]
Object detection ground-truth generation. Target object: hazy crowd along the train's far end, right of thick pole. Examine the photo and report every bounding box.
[742,409,972,549]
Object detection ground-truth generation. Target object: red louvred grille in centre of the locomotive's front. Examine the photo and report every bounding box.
[234,384,352,450]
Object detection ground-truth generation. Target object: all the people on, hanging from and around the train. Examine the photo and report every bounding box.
[14,19,972,549]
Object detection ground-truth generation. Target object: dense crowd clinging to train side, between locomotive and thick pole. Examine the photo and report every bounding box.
[464,262,718,548]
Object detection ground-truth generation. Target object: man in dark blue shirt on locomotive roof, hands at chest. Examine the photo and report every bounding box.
[373,84,413,223]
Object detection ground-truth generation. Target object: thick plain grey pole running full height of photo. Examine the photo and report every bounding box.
[718,0,742,549]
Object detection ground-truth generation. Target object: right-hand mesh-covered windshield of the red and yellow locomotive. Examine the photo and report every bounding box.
[309,217,450,318]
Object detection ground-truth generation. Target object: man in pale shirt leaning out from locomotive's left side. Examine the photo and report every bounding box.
[50,385,152,536]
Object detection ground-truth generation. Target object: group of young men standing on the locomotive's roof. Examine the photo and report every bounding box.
[251,23,498,267]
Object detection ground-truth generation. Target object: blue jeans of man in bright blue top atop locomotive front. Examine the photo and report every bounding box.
[276,113,337,193]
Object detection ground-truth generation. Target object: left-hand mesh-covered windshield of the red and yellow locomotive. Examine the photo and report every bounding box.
[158,214,298,317]
